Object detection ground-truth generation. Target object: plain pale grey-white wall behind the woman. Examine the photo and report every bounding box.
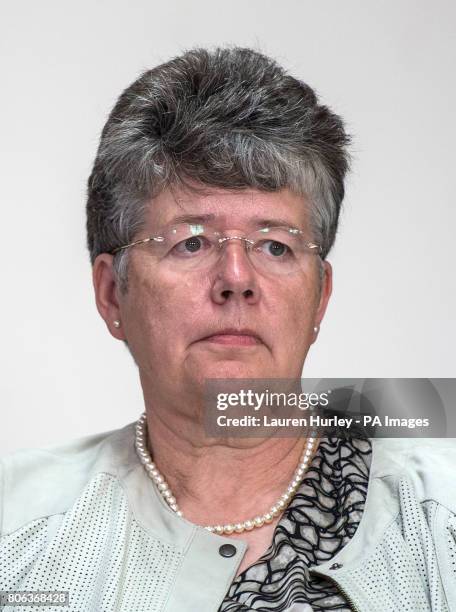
[0,0,456,454]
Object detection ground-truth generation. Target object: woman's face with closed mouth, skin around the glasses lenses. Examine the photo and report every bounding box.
[94,188,331,404]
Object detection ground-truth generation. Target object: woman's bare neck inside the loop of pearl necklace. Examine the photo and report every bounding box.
[142,401,318,525]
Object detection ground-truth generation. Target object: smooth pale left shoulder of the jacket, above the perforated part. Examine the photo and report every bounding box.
[0,423,134,535]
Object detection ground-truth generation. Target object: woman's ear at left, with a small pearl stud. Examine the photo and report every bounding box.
[92,253,126,340]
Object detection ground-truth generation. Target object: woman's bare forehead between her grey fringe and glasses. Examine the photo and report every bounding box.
[145,188,309,229]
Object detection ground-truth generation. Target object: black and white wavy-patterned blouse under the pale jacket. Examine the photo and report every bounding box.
[219,435,372,612]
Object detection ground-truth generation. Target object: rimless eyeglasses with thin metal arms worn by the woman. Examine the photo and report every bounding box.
[111,223,322,275]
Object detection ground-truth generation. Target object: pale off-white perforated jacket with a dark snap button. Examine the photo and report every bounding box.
[0,423,456,612]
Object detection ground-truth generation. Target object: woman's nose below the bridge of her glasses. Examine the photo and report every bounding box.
[211,236,260,304]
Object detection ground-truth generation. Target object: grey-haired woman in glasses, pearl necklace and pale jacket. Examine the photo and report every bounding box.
[0,48,456,612]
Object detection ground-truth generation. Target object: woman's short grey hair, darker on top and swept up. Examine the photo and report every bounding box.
[87,47,350,292]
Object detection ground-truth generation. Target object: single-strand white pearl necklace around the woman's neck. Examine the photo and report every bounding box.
[135,412,317,535]
